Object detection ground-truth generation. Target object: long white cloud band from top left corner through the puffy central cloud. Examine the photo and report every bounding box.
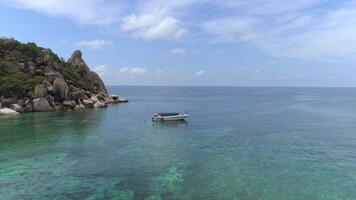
[2,0,192,40]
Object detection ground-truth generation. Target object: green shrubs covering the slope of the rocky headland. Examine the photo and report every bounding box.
[0,38,93,98]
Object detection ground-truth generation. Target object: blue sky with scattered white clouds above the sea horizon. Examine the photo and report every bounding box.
[0,0,356,87]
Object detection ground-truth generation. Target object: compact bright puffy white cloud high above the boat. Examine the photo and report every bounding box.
[121,11,186,40]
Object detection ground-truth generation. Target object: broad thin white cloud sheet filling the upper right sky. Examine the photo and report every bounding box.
[201,0,356,60]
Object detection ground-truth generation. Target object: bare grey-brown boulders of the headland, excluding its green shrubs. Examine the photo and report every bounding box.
[0,38,127,115]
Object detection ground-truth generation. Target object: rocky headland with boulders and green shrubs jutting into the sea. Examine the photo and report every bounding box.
[0,38,127,115]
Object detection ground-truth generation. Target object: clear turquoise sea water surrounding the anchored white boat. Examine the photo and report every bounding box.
[0,87,356,200]
